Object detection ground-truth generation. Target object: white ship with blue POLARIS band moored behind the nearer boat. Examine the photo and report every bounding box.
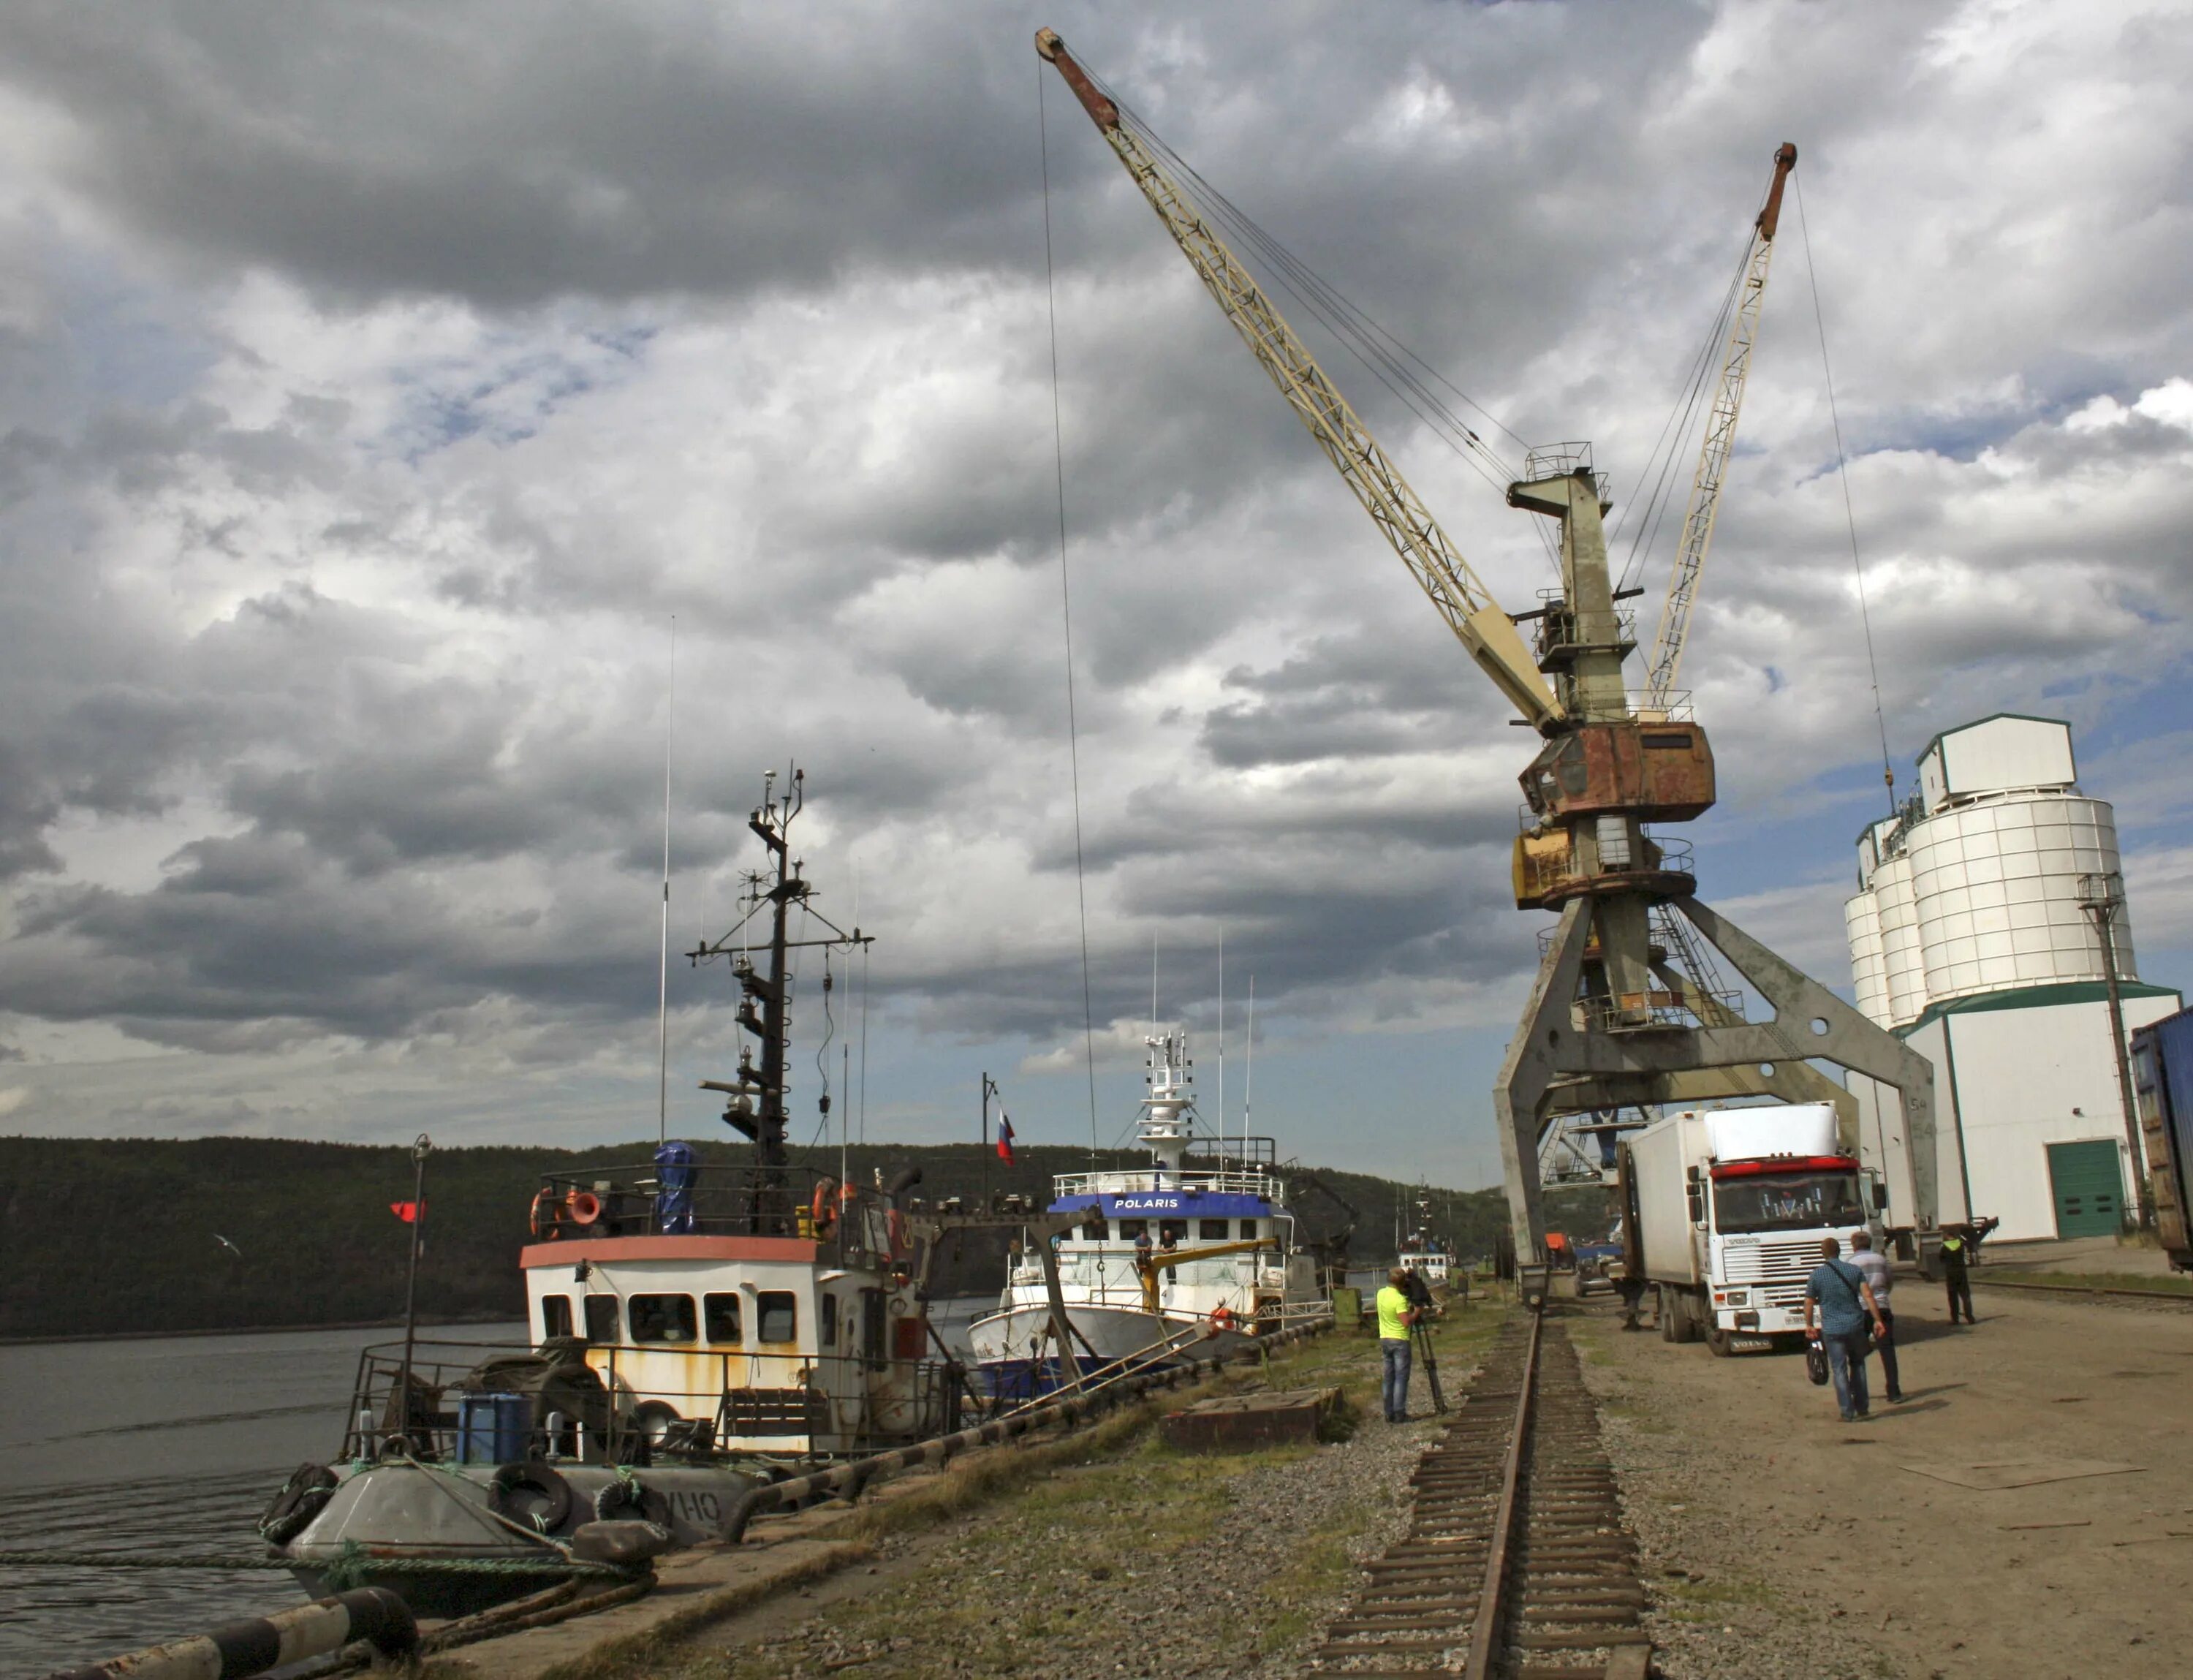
[967,1031,1329,1395]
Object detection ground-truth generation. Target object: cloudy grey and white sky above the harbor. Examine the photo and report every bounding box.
[0,0,2193,1182]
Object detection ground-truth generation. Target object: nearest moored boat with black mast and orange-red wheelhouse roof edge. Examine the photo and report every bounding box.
[261,772,963,1614]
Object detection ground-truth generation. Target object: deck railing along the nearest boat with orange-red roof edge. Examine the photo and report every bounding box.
[340,1338,982,1465]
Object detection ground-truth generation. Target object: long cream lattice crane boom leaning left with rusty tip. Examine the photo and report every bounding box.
[1035,29,1566,733]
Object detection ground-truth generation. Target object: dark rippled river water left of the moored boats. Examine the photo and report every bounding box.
[0,1298,993,1680]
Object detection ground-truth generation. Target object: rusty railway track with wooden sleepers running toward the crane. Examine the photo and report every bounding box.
[1311,1314,1651,1680]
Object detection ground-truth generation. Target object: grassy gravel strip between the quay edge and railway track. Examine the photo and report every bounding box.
[660,1309,1498,1680]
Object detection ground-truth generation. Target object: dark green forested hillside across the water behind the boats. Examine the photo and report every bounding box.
[0,1138,1597,1336]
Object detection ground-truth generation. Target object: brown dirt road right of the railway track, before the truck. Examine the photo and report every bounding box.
[1572,1279,2193,1680]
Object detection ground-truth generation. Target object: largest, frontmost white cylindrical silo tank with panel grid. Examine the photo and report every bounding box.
[1906,794,2138,998]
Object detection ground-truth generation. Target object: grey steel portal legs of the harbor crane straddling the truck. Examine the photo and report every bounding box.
[1493,899,1939,1261]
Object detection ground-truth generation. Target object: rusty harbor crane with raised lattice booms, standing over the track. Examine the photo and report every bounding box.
[1035,29,1936,1263]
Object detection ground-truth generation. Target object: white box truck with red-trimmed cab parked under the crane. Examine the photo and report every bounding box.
[1621,1103,1884,1355]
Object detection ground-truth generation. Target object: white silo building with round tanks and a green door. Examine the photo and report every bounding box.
[1844,713,2180,1241]
